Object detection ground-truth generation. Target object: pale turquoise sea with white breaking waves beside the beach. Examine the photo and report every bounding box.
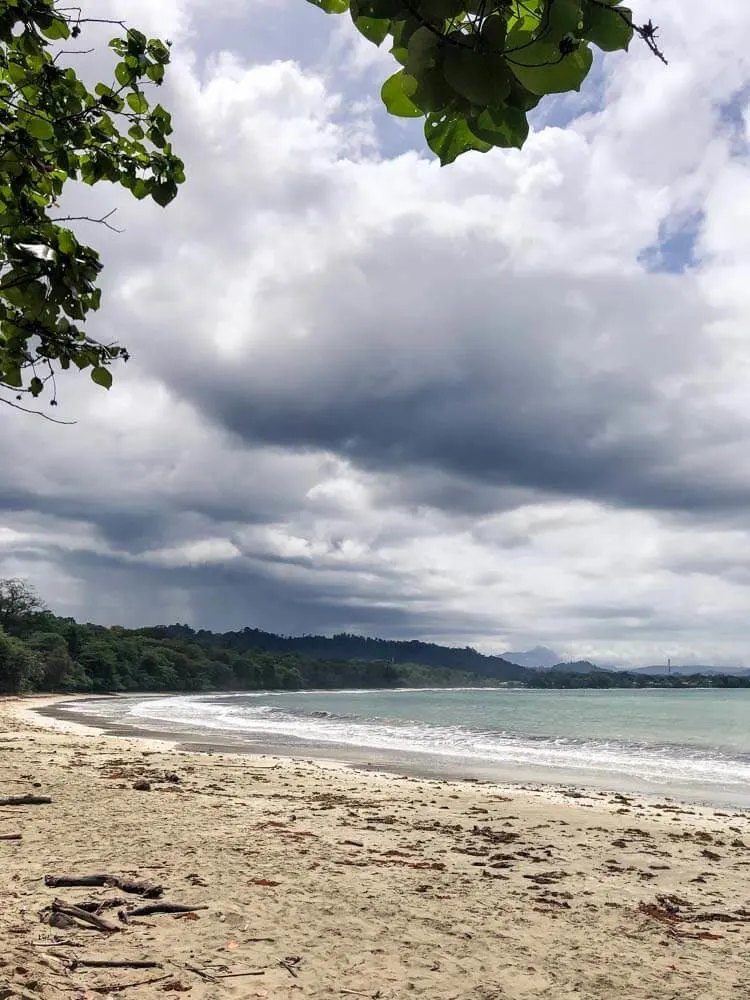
[65,688,750,808]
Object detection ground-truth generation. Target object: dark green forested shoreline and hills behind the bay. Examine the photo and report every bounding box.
[0,580,750,694]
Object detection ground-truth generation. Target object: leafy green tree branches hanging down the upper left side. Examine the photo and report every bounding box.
[0,0,185,408]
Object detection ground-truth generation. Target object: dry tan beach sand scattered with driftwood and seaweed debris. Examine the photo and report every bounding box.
[0,699,750,1000]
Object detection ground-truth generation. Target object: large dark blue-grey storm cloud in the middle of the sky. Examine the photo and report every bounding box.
[154,231,750,514]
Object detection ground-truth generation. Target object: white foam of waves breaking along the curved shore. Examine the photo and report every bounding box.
[61,689,750,792]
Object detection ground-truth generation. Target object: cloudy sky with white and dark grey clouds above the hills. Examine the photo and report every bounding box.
[0,0,750,664]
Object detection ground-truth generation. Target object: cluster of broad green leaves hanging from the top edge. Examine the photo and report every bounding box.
[310,0,664,164]
